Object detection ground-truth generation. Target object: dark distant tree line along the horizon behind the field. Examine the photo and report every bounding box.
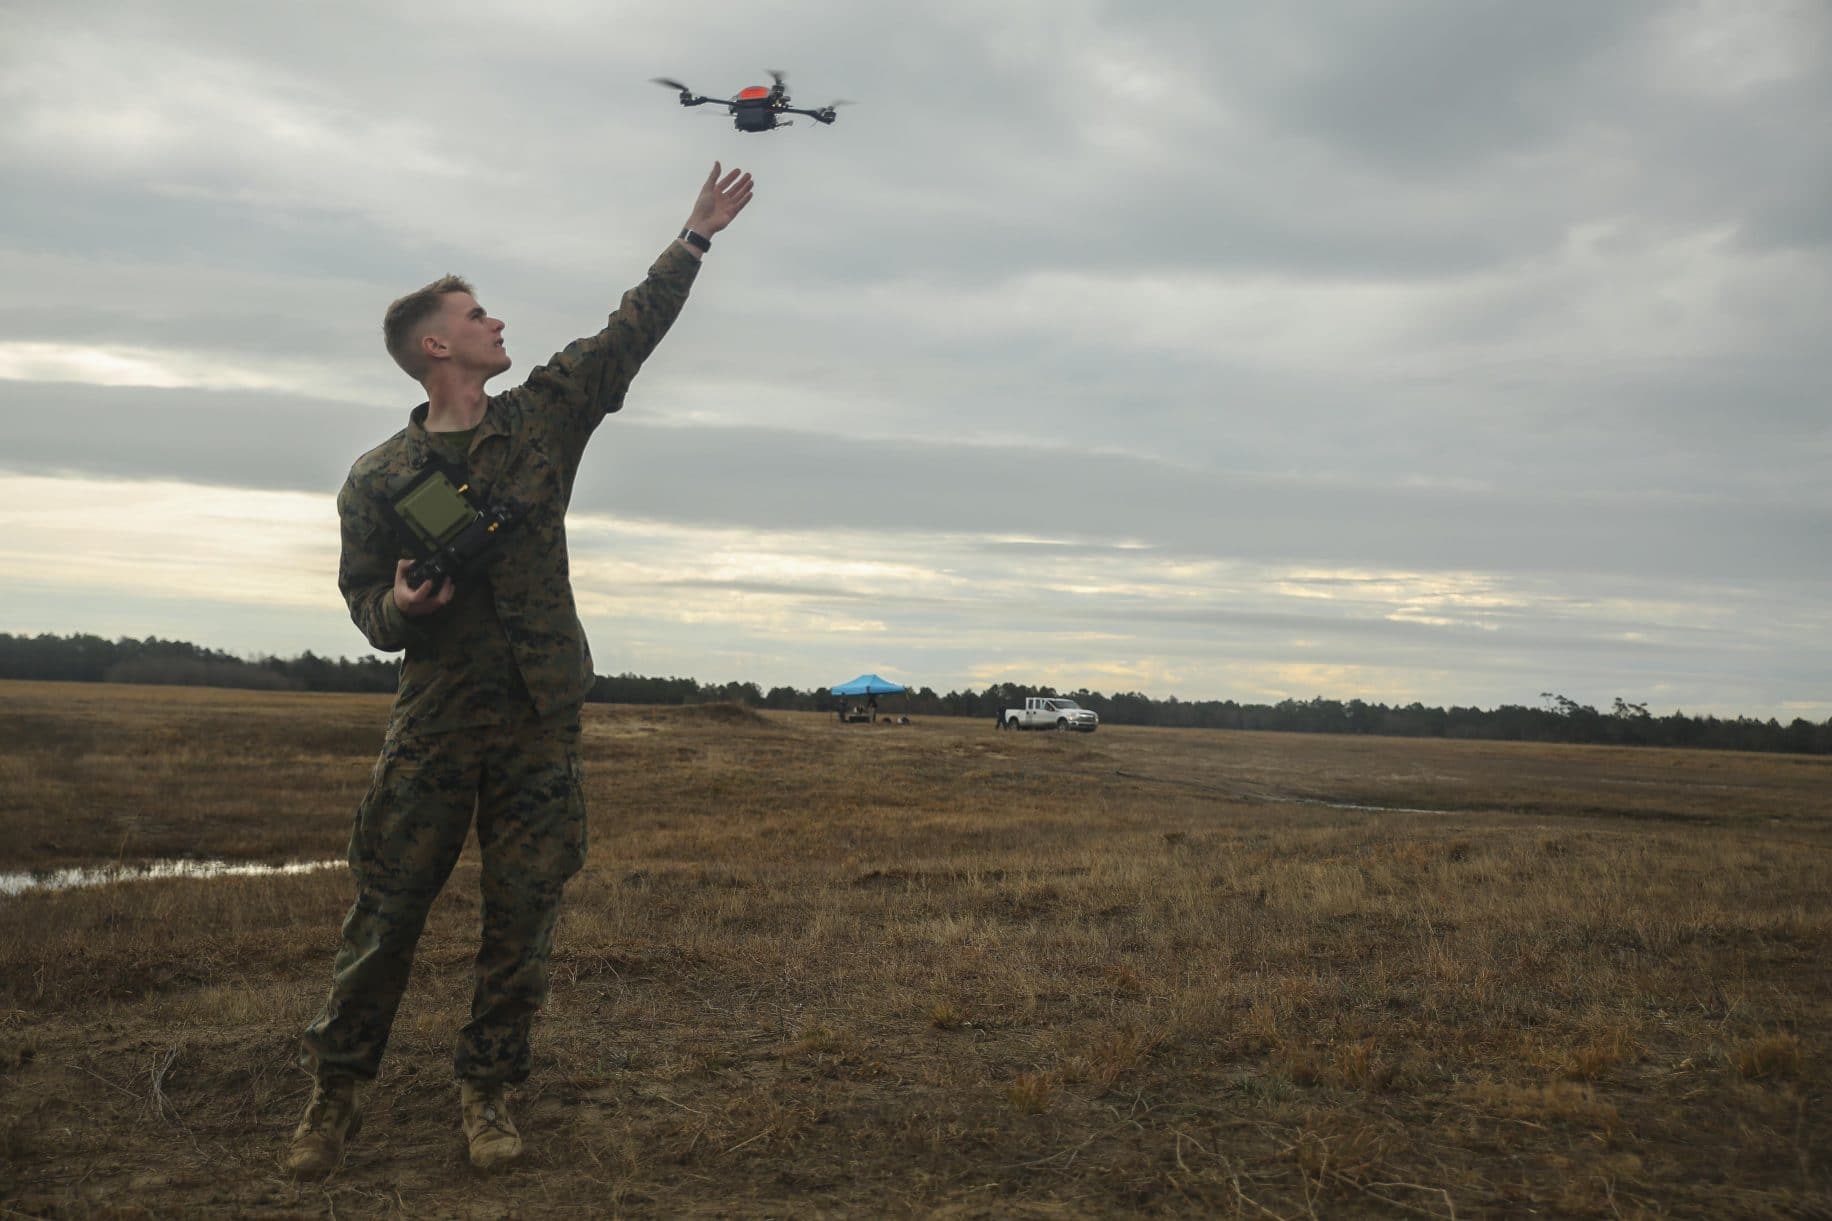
[0,633,1832,755]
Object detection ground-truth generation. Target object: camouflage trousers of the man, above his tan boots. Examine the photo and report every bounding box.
[300,711,586,1085]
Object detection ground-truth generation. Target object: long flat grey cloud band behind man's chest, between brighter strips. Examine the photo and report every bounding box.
[0,383,1832,579]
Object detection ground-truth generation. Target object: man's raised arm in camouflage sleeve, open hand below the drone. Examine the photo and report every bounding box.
[511,161,751,473]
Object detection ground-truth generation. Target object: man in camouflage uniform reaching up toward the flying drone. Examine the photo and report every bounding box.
[286,163,751,1175]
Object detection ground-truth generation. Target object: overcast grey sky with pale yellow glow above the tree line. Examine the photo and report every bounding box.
[0,0,1832,721]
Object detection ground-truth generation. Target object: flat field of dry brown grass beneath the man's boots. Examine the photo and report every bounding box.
[0,684,1832,1217]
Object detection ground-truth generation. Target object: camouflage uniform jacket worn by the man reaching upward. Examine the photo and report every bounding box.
[337,244,700,733]
